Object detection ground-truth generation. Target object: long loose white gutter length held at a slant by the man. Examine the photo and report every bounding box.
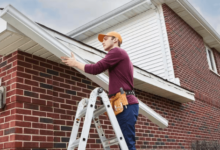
[1,5,168,128]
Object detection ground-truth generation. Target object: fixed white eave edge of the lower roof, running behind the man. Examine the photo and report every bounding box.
[46,29,195,103]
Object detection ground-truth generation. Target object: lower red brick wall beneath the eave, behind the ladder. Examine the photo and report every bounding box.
[0,51,220,150]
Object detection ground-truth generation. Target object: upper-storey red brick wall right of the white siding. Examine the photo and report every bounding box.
[163,4,220,105]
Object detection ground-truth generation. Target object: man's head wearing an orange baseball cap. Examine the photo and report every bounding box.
[98,32,122,51]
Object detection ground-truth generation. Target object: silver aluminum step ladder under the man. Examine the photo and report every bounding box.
[67,88,128,150]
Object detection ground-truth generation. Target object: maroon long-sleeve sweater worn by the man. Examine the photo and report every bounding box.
[85,47,138,104]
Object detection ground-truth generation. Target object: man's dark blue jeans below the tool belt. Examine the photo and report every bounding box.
[116,104,139,150]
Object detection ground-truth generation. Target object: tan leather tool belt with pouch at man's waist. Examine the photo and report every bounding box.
[105,88,134,116]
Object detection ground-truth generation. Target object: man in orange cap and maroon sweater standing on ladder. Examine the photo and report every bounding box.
[61,32,139,150]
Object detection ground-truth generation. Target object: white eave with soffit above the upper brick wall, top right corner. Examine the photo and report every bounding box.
[152,0,220,52]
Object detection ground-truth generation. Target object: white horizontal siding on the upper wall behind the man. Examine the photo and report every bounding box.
[83,8,175,82]
